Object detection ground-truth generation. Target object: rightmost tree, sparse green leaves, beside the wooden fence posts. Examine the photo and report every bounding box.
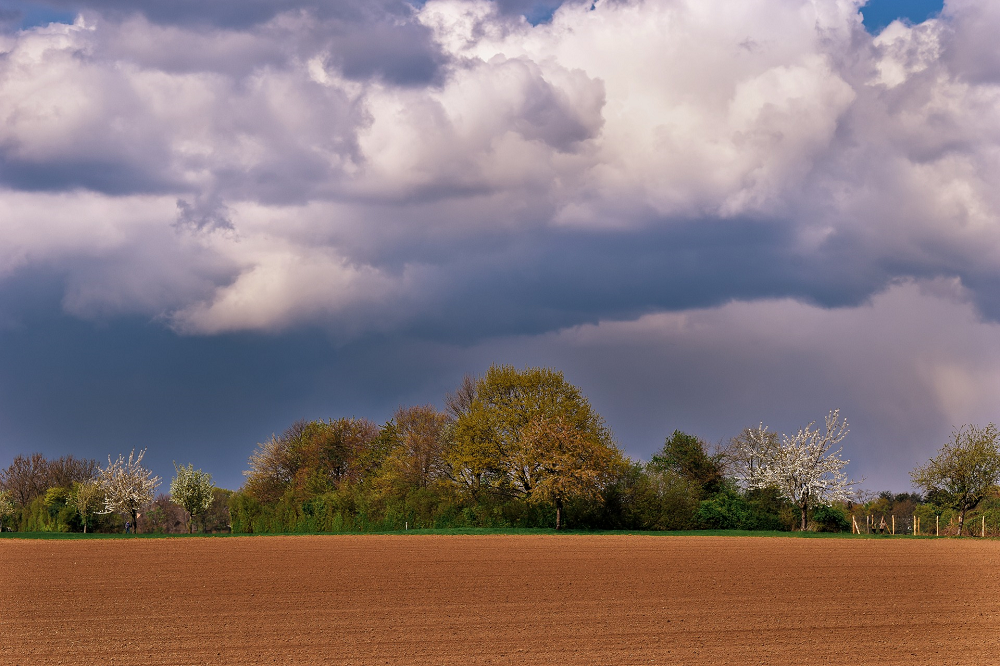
[910,423,1000,536]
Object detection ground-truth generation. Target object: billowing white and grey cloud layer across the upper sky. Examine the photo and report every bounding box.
[0,0,1000,339]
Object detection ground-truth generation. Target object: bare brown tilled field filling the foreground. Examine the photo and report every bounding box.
[0,536,1000,665]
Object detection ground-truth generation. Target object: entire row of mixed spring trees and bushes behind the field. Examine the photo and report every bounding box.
[0,365,1000,533]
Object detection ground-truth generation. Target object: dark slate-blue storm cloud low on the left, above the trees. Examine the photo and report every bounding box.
[0,270,464,492]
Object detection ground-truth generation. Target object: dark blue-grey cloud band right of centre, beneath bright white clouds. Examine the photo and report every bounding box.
[396,220,900,342]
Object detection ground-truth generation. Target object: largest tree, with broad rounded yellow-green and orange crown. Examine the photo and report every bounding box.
[444,365,624,519]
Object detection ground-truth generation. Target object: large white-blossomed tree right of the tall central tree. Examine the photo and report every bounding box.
[742,409,858,530]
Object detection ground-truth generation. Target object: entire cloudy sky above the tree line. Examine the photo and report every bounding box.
[0,0,1000,492]
